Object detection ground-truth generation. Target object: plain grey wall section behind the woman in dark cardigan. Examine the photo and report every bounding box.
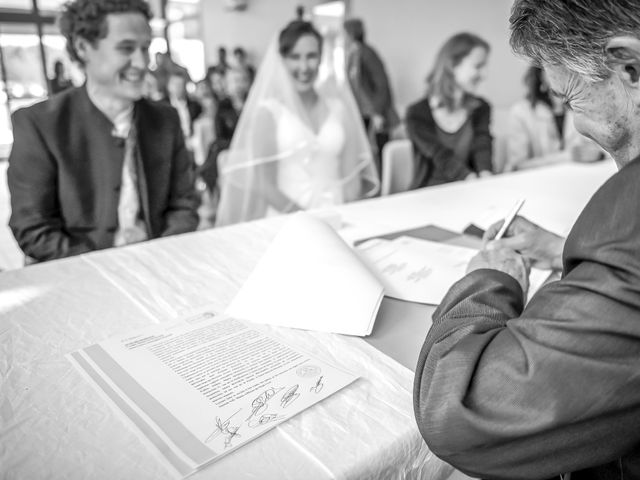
[351,0,524,114]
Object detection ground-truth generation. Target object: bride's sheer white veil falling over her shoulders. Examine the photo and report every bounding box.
[216,22,380,225]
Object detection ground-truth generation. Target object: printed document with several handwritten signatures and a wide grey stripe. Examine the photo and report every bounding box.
[68,314,357,477]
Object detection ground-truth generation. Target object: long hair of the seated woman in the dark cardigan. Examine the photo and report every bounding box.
[427,32,491,110]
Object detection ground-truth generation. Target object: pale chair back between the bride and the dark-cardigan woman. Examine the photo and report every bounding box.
[380,139,415,195]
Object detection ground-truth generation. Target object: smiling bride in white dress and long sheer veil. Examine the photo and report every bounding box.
[216,21,379,225]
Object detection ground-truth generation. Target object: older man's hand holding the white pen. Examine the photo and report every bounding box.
[483,216,565,270]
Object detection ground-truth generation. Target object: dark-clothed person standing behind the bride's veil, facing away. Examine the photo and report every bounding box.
[344,18,400,171]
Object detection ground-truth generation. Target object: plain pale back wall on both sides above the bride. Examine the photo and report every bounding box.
[202,0,526,126]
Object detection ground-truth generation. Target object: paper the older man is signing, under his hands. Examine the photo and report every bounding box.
[356,236,550,305]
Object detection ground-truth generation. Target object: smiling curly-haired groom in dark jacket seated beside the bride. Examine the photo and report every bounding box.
[7,0,198,262]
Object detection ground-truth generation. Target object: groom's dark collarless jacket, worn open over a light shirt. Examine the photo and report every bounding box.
[7,87,198,261]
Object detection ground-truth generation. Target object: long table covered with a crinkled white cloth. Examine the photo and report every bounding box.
[0,159,615,479]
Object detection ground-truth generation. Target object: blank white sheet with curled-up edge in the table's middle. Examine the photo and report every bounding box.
[226,213,384,336]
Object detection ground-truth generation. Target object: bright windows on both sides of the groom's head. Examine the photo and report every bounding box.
[0,0,204,159]
